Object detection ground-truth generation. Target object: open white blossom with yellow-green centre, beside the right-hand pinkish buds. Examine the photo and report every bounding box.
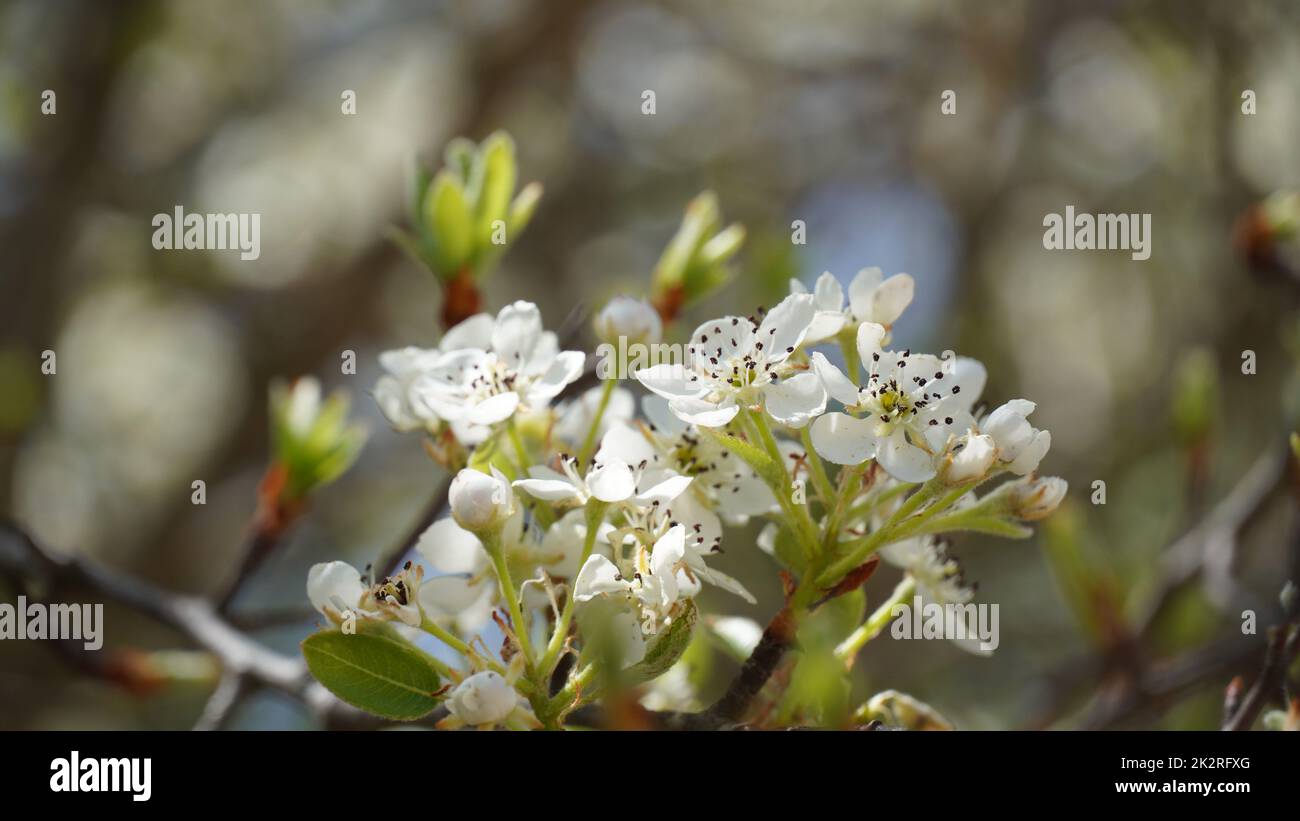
[811,322,987,482]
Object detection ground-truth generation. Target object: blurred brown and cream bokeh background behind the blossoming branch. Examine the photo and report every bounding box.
[0,0,1300,729]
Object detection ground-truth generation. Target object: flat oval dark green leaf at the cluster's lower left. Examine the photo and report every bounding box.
[302,630,442,721]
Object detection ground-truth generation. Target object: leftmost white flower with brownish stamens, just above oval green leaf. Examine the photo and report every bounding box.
[307,561,424,627]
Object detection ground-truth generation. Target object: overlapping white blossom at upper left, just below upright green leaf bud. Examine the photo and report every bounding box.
[412,301,586,426]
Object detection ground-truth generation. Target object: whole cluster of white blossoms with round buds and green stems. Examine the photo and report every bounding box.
[307,269,1066,726]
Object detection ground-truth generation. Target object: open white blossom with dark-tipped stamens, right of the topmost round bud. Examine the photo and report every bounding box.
[636,294,826,427]
